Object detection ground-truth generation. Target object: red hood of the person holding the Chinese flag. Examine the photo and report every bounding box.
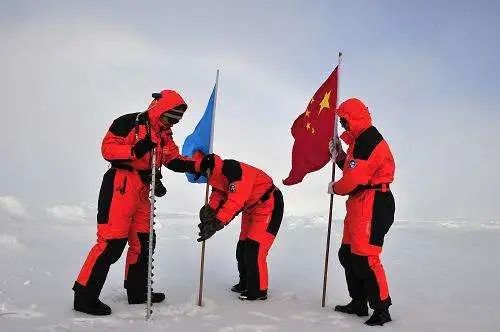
[336,98,372,144]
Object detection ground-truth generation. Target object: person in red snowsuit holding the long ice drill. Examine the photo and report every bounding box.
[73,90,202,315]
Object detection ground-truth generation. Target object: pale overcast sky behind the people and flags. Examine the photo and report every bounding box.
[0,0,500,221]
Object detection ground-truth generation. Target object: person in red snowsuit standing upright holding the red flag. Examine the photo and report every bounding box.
[328,98,395,325]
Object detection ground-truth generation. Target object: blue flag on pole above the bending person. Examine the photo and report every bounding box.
[182,83,217,183]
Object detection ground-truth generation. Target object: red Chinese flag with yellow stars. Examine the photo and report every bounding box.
[283,67,338,186]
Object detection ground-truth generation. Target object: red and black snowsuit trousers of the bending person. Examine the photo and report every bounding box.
[236,188,284,296]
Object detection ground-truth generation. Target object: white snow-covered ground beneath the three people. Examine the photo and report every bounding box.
[0,205,500,332]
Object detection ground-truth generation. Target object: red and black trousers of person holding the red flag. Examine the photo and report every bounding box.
[338,185,395,309]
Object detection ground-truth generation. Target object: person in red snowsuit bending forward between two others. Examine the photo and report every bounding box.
[198,154,284,301]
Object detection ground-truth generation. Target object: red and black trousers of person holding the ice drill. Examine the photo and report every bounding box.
[73,168,156,300]
